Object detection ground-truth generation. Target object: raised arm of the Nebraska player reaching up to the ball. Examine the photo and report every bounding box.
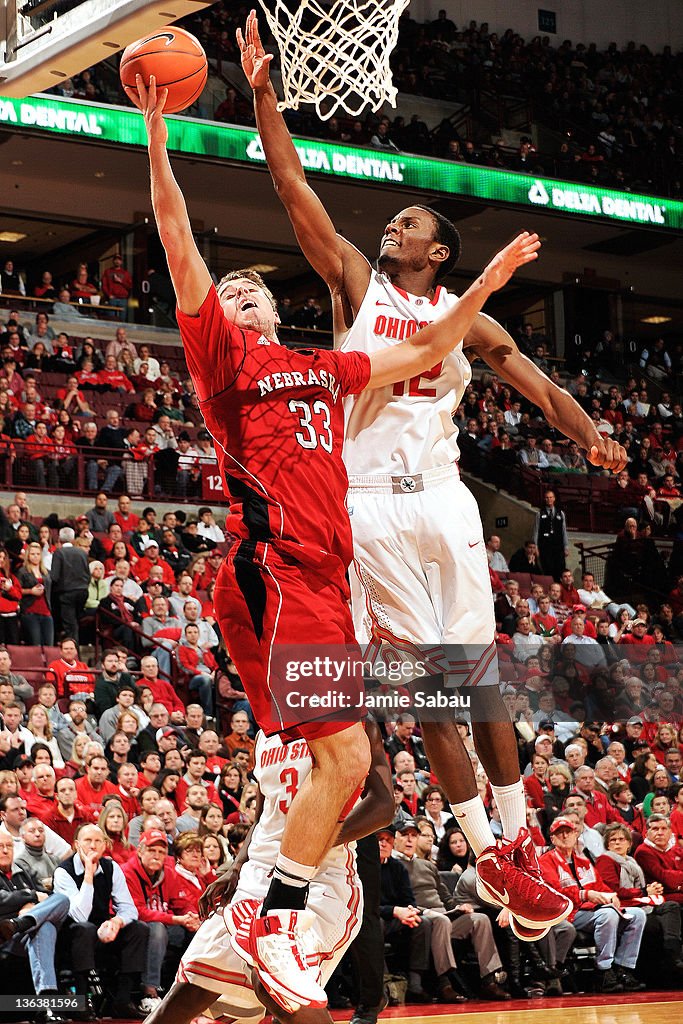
[126,75,211,316]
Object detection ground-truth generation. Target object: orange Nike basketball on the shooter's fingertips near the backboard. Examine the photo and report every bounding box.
[119,25,209,114]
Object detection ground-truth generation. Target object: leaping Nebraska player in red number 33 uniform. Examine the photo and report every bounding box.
[127,76,540,1006]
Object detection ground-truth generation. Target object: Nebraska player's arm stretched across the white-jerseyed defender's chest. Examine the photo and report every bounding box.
[368,231,541,388]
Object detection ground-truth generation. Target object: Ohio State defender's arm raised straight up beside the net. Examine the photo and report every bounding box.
[237,10,371,309]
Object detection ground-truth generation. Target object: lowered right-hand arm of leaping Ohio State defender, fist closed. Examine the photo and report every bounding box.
[464,314,627,473]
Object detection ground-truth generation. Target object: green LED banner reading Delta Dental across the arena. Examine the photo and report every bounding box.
[0,95,683,231]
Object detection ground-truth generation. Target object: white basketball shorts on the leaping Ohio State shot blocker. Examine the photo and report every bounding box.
[346,464,499,685]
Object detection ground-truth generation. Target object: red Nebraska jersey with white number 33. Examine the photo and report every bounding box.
[177,286,370,571]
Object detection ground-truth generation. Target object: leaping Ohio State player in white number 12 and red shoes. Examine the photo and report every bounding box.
[238,11,626,939]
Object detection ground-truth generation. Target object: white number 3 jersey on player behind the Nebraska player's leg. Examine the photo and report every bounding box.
[250,732,355,876]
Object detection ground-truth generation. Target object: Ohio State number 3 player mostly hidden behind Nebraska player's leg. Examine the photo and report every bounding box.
[147,721,394,1024]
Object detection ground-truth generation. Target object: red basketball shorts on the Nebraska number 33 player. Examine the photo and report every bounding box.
[213,541,365,740]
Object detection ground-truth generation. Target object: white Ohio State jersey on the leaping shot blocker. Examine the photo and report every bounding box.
[340,270,472,484]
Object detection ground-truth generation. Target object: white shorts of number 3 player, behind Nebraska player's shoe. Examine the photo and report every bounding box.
[177,851,362,1024]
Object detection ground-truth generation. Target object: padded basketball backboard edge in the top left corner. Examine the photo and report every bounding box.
[0,0,211,98]
